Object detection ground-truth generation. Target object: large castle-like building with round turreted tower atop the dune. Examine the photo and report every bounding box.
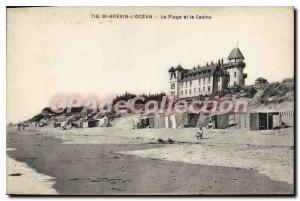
[169,47,247,99]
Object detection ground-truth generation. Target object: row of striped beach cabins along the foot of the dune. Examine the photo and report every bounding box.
[134,111,294,130]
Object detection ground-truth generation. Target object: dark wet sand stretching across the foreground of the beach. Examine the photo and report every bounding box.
[8,133,293,195]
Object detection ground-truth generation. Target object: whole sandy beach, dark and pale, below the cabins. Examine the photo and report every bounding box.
[7,116,294,195]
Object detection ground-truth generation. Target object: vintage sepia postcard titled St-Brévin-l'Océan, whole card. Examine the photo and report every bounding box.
[6,7,296,196]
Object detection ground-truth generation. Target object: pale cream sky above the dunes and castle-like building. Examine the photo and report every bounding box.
[7,7,294,122]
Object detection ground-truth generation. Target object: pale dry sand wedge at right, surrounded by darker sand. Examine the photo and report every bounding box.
[120,144,294,184]
